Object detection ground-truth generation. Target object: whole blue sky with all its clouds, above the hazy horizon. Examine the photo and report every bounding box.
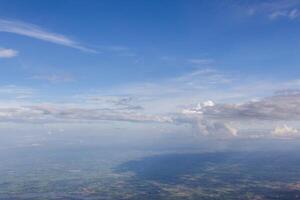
[0,0,300,142]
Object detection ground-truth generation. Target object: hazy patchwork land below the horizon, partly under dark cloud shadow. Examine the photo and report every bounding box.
[0,147,300,200]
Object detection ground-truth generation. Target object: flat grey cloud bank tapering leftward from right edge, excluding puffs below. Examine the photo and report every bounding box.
[185,93,300,120]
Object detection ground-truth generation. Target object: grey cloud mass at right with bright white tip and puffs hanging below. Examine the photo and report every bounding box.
[176,92,300,136]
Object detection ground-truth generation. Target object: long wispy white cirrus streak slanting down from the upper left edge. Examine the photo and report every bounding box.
[0,19,97,53]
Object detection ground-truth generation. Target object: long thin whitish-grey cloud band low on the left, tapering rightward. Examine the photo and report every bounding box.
[0,104,172,123]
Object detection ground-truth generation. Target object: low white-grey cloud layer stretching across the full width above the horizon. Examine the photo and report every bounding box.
[0,86,300,137]
